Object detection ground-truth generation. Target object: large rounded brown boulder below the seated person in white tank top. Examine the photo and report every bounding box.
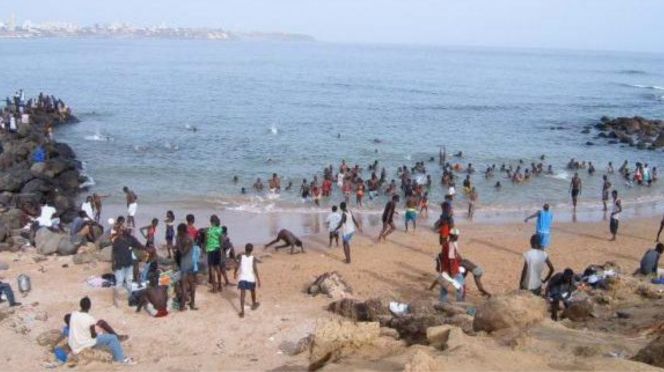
[473,291,547,333]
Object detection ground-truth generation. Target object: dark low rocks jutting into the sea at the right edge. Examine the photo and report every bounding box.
[595,116,664,150]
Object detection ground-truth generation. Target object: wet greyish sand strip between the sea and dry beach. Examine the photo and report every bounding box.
[102,195,664,247]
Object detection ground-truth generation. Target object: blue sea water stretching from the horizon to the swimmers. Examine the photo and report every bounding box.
[0,39,664,221]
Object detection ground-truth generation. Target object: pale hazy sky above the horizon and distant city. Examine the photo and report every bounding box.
[0,0,664,52]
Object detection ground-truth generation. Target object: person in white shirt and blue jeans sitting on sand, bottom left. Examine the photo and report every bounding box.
[67,297,135,364]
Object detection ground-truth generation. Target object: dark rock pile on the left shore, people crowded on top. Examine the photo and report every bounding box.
[0,98,85,250]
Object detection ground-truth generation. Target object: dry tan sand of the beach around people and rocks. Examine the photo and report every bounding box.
[0,211,659,371]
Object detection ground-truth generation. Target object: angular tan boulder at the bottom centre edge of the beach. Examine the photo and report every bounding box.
[309,319,380,369]
